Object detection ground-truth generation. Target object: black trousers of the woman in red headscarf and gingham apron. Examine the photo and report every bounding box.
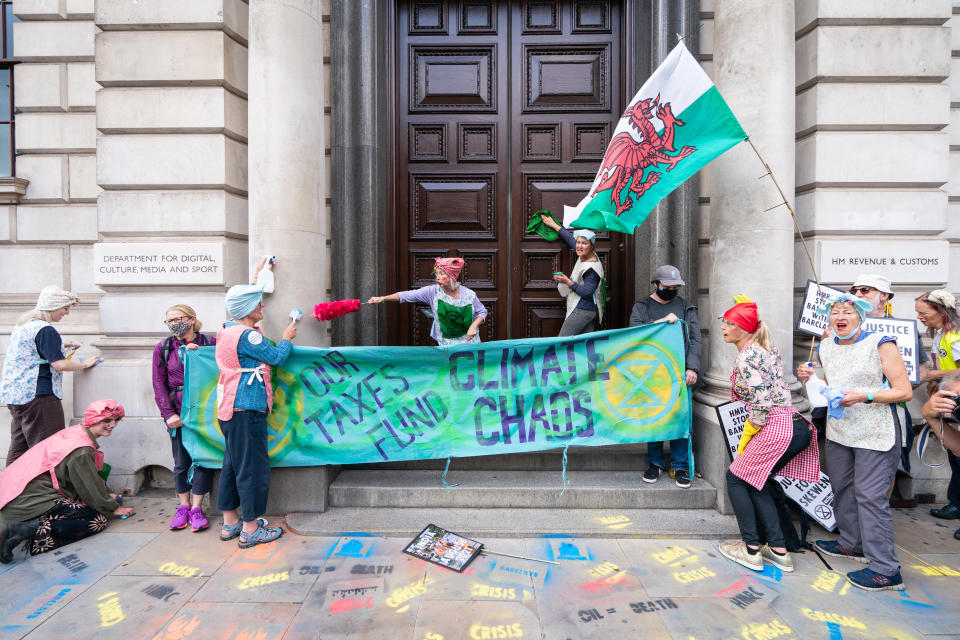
[727,420,810,547]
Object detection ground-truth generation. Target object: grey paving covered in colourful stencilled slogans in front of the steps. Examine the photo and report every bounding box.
[0,492,960,640]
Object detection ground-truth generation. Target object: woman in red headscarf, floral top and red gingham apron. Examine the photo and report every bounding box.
[718,296,820,571]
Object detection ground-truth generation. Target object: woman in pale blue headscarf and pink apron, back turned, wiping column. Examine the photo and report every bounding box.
[215,284,297,549]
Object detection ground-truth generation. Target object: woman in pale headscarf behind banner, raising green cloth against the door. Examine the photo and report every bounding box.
[540,214,606,338]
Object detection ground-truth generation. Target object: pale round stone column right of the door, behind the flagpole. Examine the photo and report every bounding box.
[694,0,795,510]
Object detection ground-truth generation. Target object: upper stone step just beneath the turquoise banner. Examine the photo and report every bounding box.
[330,469,717,509]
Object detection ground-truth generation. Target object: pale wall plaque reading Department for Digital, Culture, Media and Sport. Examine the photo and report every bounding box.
[93,242,224,285]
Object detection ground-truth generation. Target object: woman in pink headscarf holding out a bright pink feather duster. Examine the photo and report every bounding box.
[367,258,487,347]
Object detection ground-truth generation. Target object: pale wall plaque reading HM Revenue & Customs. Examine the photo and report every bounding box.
[817,239,950,288]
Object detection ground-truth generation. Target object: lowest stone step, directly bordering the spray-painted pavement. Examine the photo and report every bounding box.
[286,507,739,548]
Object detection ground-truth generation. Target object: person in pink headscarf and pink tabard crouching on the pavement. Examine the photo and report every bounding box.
[0,399,133,563]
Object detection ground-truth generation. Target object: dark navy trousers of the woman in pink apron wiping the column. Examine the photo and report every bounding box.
[217,411,270,522]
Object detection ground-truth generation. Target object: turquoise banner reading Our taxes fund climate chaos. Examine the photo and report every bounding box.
[182,323,690,467]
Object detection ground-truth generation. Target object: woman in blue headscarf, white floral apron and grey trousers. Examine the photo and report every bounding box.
[797,293,913,591]
